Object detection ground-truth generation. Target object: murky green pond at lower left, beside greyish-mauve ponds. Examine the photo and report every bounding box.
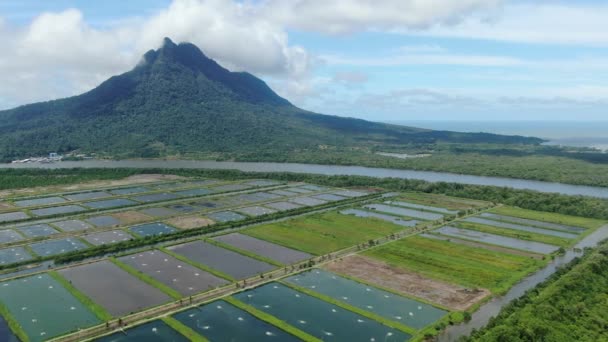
[0,274,101,341]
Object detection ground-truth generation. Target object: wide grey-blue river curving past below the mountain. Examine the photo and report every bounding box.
[0,160,608,198]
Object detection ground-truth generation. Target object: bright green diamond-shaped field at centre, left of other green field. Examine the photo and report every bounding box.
[242,212,404,255]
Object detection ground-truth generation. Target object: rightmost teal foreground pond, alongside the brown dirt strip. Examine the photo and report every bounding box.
[285,269,448,329]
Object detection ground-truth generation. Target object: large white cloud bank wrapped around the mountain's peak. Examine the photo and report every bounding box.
[0,0,314,108]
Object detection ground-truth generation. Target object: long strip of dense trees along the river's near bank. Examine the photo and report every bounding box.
[0,168,608,220]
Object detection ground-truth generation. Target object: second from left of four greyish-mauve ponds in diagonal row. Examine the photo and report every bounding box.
[118,250,228,296]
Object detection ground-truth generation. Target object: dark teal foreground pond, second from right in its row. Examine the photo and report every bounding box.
[234,283,411,342]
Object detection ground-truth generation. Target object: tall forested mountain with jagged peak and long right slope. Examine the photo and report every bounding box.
[0,38,540,161]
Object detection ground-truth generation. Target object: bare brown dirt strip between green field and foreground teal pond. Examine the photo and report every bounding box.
[324,255,490,311]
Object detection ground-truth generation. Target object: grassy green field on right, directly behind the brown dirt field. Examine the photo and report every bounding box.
[363,236,544,293]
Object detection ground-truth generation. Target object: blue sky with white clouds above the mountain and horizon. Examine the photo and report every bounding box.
[0,0,608,121]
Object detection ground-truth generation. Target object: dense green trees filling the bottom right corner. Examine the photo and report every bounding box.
[465,242,608,342]
